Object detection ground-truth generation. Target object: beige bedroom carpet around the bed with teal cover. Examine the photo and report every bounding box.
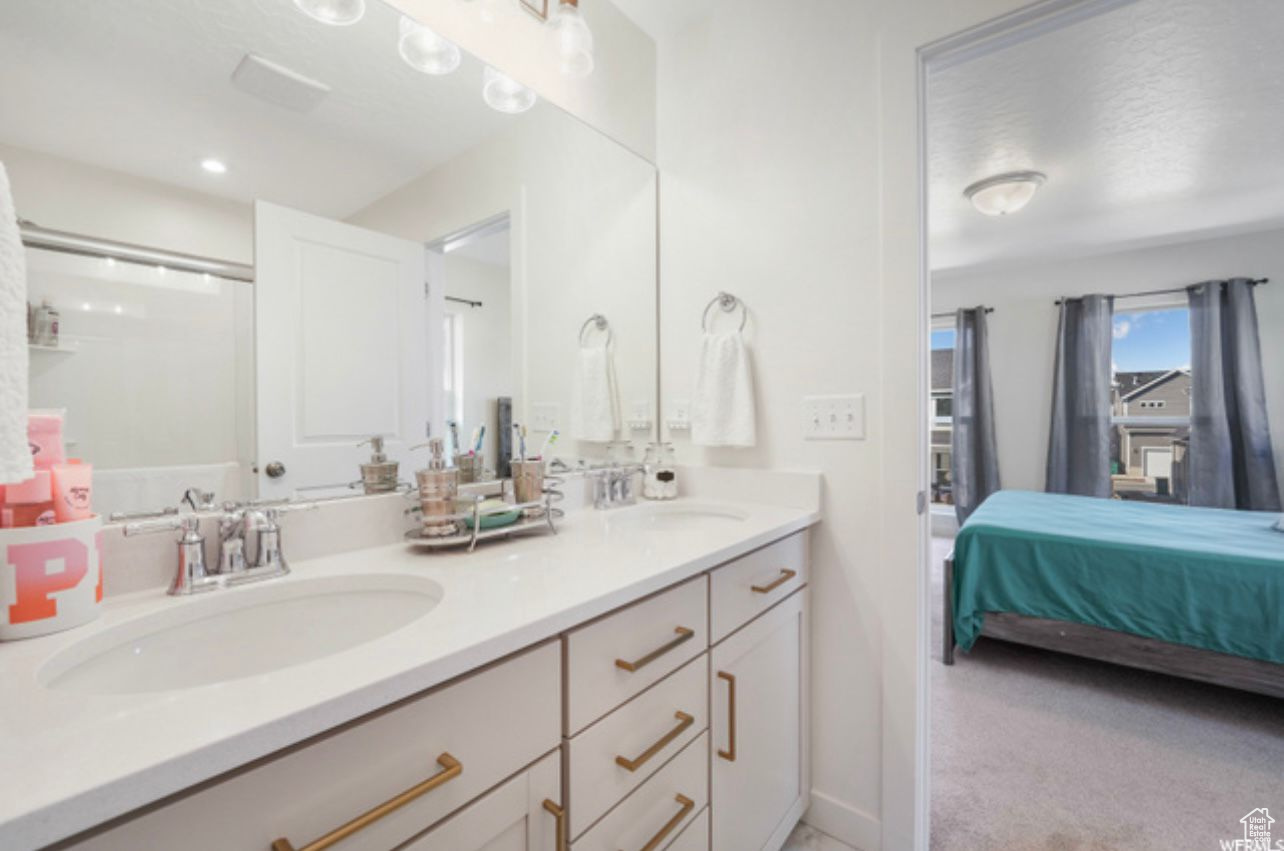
[931,539,1284,851]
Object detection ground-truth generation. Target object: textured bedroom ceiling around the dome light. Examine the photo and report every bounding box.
[928,0,1284,270]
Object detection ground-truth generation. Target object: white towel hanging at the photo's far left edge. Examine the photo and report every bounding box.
[0,163,35,483]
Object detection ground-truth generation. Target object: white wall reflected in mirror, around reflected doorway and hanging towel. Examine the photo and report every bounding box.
[349,109,656,467]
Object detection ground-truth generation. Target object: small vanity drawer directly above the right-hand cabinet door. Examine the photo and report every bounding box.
[709,531,808,644]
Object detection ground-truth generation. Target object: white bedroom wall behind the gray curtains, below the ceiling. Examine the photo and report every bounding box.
[932,230,1284,490]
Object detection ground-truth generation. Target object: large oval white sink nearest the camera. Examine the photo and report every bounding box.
[37,574,443,694]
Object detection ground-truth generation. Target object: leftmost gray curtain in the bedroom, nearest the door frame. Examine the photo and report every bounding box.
[950,307,1003,522]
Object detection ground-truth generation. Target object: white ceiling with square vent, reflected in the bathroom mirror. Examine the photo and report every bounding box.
[0,0,541,217]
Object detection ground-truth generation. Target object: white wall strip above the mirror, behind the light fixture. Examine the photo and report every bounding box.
[389,0,655,160]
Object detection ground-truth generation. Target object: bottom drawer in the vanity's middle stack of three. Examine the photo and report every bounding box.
[571,733,709,851]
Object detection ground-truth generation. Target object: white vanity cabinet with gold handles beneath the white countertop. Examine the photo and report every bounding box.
[56,531,810,851]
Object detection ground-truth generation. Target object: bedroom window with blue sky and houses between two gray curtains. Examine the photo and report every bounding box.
[1111,305,1190,502]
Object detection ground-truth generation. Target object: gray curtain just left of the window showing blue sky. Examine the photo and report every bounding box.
[1046,295,1115,497]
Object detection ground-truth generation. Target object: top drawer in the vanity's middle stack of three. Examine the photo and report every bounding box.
[566,576,709,733]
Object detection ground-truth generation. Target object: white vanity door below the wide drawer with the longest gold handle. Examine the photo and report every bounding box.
[398,751,562,851]
